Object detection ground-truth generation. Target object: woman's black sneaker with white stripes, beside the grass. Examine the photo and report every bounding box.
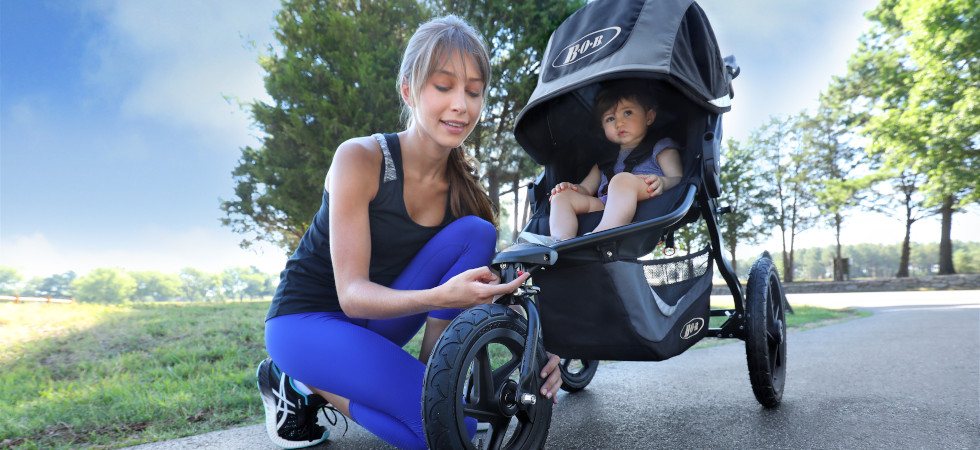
[255,358,330,448]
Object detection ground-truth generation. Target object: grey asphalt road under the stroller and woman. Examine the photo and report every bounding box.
[126,291,980,450]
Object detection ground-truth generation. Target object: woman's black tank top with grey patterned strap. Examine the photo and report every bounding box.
[266,134,455,320]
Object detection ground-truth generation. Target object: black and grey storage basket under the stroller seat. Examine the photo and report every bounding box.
[534,248,712,361]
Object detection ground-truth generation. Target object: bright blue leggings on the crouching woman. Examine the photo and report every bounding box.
[265,216,497,449]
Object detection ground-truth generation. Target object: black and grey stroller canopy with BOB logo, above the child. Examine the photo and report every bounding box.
[515,0,731,164]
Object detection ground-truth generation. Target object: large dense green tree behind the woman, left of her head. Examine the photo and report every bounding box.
[221,0,426,252]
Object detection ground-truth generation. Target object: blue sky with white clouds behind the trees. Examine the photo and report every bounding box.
[0,0,980,276]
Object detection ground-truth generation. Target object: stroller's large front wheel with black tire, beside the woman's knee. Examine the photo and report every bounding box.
[422,304,552,449]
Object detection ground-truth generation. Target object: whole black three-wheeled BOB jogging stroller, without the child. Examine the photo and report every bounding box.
[422,0,788,449]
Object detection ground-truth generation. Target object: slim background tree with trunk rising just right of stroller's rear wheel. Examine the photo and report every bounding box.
[748,114,816,283]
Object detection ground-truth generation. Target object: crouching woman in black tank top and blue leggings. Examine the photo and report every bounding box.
[257,16,561,448]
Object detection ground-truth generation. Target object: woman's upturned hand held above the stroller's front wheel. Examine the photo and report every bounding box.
[433,267,531,309]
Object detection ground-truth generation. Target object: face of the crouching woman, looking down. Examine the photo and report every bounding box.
[402,55,483,148]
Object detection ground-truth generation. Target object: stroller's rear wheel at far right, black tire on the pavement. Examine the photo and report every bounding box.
[745,255,786,408]
